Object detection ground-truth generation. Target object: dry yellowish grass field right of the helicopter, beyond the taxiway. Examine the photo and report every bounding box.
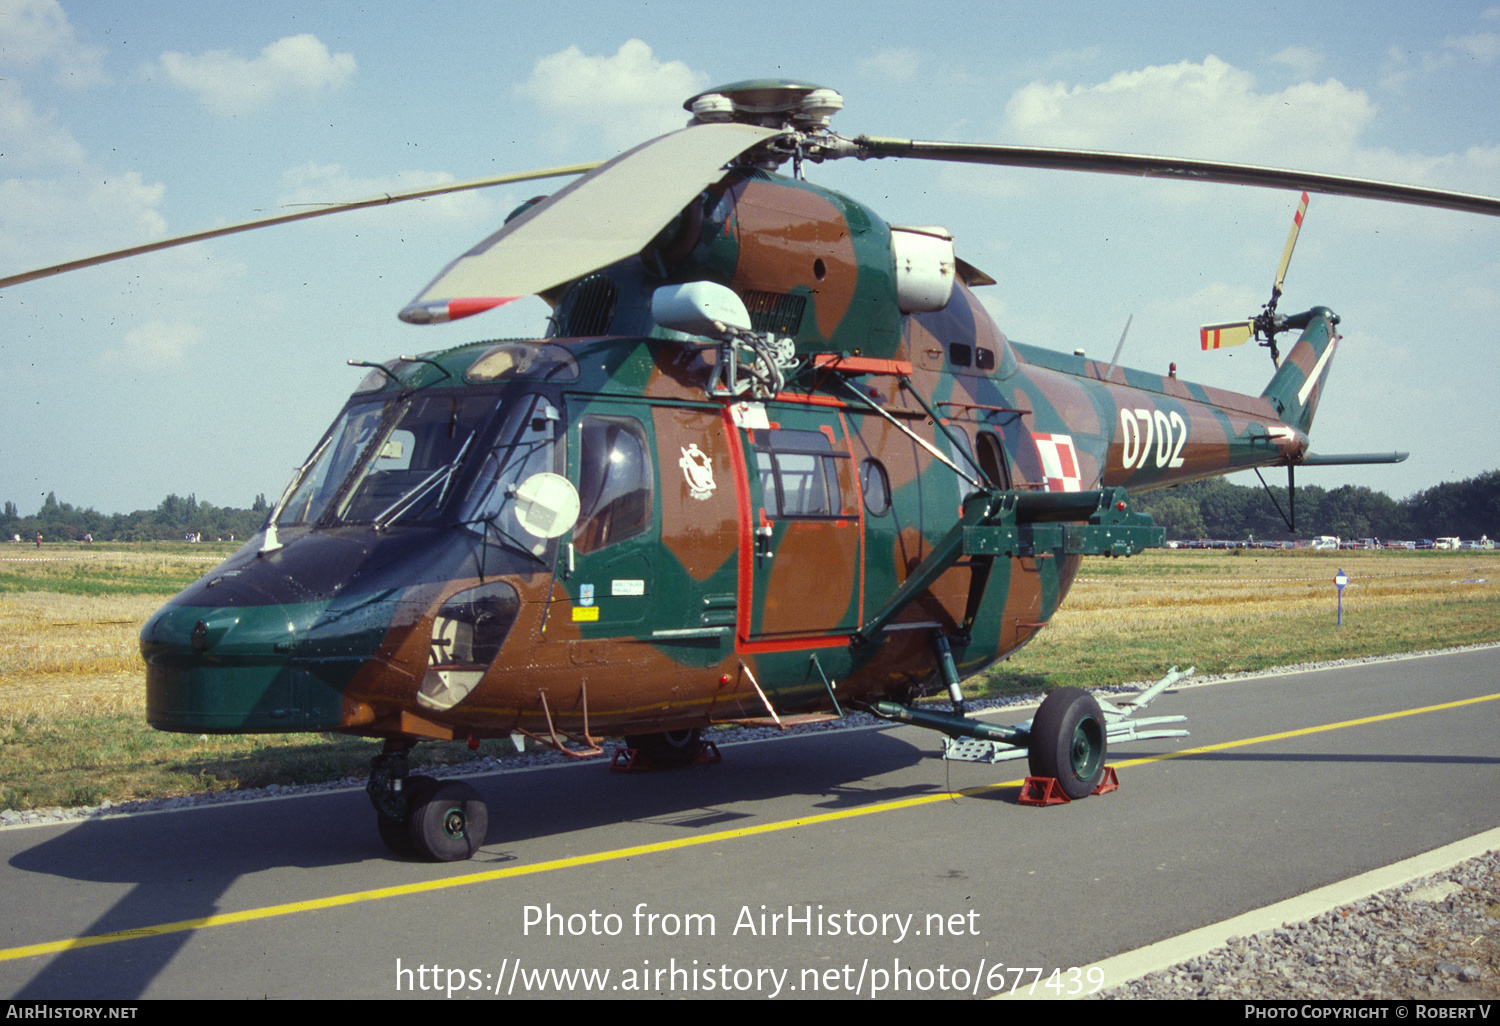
[984,552,1500,692]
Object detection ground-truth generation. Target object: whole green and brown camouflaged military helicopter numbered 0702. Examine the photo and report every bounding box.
[0,80,1500,861]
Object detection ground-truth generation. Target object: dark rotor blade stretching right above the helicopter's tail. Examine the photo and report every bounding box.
[854,135,1500,218]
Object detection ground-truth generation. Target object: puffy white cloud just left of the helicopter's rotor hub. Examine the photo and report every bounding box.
[516,39,708,147]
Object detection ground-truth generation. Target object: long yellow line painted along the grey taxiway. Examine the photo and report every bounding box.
[0,693,1500,962]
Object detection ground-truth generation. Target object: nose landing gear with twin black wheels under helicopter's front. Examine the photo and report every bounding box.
[365,740,489,863]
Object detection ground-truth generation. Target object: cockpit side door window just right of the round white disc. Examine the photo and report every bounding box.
[573,417,653,552]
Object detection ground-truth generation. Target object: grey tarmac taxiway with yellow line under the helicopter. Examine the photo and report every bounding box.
[0,648,1500,999]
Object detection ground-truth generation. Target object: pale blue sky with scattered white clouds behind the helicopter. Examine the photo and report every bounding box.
[0,0,1500,515]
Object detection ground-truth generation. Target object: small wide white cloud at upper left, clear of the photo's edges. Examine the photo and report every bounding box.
[161,35,356,116]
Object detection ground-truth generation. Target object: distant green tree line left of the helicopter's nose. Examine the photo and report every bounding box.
[0,492,272,542]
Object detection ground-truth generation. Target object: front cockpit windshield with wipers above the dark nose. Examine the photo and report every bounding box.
[276,390,510,527]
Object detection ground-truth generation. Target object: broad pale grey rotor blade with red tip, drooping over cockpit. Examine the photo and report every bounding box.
[401,122,780,324]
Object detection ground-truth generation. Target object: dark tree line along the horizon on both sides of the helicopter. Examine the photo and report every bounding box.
[0,470,1500,542]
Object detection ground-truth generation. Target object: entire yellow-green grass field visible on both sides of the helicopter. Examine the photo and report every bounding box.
[0,545,1500,809]
